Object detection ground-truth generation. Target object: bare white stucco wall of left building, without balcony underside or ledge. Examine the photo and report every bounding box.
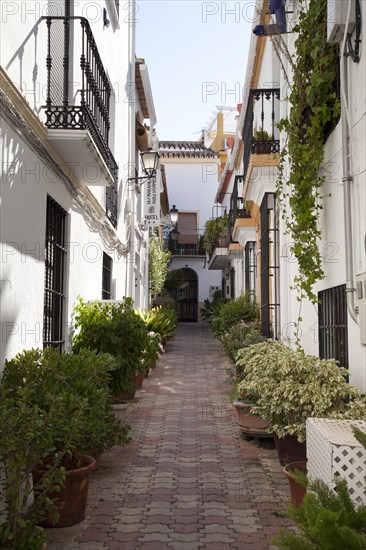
[0,0,143,370]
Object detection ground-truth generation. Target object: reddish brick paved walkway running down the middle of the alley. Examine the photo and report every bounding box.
[48,324,289,550]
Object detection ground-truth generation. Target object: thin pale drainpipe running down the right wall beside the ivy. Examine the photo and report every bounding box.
[341,0,358,323]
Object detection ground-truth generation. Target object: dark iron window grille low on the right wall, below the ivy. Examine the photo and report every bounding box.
[318,285,349,369]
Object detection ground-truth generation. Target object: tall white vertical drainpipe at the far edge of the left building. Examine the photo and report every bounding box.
[126,0,136,298]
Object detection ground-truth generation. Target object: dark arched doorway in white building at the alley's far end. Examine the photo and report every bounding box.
[176,267,198,322]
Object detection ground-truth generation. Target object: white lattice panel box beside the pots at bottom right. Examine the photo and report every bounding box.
[306,418,366,505]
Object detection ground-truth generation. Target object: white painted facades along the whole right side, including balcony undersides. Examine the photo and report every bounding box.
[220,0,366,391]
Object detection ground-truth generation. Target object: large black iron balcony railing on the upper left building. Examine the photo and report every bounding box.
[45,16,118,188]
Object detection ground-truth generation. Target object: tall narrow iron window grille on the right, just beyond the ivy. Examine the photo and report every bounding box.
[260,193,280,338]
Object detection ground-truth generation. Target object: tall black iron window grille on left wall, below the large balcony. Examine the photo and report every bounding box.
[43,196,67,353]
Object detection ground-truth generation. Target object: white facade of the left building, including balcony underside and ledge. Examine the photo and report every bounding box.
[0,0,160,370]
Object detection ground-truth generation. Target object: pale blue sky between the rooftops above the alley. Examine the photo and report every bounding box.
[136,0,255,141]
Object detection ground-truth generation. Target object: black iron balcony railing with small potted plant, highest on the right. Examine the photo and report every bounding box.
[243,88,280,178]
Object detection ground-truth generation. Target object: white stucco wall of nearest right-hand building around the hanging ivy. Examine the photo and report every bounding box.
[280,5,366,391]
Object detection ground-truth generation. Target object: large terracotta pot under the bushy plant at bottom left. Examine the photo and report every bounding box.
[32,455,95,527]
